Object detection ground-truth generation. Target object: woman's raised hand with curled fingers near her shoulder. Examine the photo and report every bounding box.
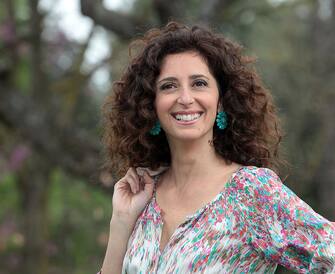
[112,168,154,226]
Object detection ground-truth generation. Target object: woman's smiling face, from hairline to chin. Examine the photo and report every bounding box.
[155,51,219,141]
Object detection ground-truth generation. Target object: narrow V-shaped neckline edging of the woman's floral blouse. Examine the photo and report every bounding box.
[152,166,245,255]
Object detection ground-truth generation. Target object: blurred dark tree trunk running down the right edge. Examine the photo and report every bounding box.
[311,0,335,218]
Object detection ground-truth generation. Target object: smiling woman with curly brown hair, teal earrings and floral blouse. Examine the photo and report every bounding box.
[101,22,335,274]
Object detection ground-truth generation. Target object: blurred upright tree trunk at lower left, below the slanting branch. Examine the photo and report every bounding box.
[18,152,50,274]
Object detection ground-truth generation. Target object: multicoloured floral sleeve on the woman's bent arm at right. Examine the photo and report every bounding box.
[240,168,335,273]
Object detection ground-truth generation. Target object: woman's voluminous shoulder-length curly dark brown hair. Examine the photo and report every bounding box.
[103,22,282,176]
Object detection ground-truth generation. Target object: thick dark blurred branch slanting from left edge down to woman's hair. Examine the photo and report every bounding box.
[0,84,113,193]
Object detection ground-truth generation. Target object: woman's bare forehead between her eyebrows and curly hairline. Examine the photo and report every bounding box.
[158,51,210,78]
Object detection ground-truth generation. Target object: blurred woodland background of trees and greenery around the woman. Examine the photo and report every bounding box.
[0,0,335,274]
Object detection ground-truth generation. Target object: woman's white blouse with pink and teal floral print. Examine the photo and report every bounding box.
[122,166,335,274]
